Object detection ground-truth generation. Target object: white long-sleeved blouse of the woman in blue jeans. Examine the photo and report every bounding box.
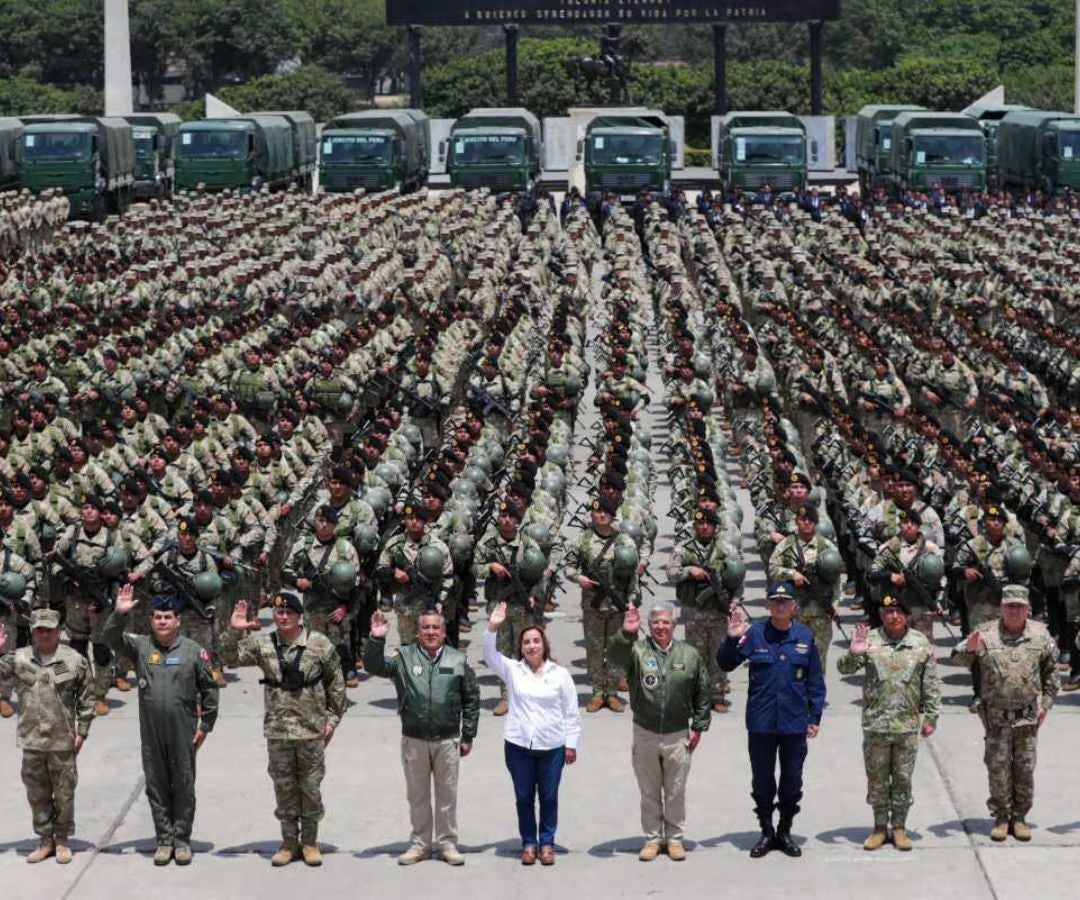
[484,631,581,750]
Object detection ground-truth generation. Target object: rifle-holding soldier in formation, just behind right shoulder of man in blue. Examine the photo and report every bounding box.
[769,503,843,670]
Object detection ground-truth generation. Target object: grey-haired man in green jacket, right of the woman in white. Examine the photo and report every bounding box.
[611,604,713,862]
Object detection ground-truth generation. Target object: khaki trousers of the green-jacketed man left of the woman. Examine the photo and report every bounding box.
[402,735,461,852]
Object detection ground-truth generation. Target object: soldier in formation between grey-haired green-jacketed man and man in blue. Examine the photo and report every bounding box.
[667,509,739,713]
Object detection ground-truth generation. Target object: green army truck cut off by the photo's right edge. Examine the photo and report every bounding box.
[997,109,1080,194]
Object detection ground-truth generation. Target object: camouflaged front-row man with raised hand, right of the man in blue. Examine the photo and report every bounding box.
[837,592,942,850]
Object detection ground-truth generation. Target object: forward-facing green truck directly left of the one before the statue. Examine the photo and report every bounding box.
[438,107,543,193]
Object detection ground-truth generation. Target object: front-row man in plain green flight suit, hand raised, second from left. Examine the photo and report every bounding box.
[104,585,217,865]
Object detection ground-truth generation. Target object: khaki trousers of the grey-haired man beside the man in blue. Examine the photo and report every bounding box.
[631,724,690,844]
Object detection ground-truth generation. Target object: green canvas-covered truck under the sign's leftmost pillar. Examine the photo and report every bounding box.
[319,109,431,192]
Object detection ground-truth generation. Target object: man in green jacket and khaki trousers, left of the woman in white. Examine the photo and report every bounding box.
[364,610,480,865]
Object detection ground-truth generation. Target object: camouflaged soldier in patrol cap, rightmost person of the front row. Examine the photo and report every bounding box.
[954,585,1059,841]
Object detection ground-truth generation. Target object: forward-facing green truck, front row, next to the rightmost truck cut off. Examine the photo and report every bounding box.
[889,112,986,197]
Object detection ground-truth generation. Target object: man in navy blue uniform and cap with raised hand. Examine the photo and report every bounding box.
[716,581,825,859]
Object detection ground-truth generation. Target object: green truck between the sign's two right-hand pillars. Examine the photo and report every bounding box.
[716,110,807,193]
